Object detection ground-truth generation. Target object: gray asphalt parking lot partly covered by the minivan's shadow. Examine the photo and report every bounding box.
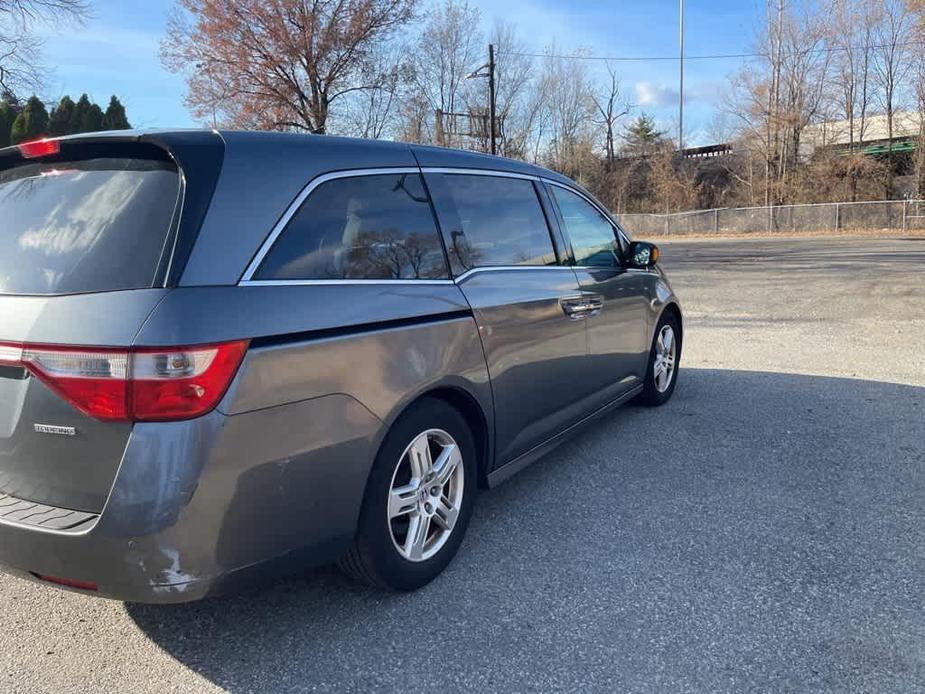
[0,237,925,692]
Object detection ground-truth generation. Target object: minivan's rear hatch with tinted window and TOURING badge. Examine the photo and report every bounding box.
[0,136,218,520]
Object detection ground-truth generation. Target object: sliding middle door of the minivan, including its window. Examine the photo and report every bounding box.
[425,169,590,465]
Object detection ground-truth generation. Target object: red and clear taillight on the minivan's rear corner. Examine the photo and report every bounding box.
[0,340,247,422]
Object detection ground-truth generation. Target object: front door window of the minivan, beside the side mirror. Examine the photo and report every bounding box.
[549,185,620,267]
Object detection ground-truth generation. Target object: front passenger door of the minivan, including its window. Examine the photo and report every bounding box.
[547,183,649,401]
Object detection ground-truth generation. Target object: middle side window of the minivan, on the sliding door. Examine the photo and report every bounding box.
[440,174,558,269]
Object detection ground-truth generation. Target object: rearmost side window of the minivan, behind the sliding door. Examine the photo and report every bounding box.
[254,174,449,280]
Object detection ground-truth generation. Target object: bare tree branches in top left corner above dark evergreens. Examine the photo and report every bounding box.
[0,0,89,95]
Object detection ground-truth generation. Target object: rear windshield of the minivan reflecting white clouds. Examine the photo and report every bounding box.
[0,158,180,294]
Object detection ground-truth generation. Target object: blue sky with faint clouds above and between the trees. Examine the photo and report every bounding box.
[44,0,762,144]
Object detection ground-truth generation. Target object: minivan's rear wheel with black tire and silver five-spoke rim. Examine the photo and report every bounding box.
[340,398,477,591]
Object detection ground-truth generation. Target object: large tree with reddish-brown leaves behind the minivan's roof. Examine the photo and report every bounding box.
[161,0,416,132]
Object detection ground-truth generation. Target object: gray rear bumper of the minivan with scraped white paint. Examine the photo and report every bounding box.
[0,395,381,603]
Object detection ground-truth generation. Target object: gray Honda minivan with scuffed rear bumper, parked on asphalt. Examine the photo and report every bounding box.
[0,131,682,602]
